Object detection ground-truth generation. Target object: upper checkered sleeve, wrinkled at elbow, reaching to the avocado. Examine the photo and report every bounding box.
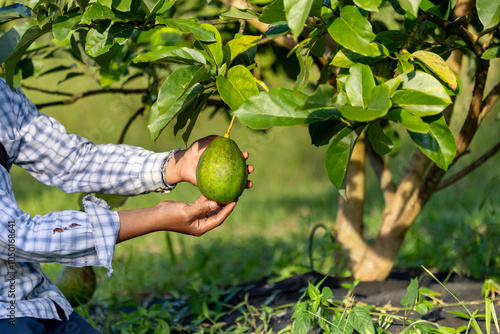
[0,79,175,196]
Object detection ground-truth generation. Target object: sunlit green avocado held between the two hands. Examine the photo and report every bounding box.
[196,137,248,204]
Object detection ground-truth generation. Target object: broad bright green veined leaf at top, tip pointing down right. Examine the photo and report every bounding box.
[327,6,380,57]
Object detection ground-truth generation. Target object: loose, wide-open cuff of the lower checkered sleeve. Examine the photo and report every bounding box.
[83,195,120,276]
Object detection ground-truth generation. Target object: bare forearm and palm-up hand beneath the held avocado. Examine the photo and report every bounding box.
[117,196,236,243]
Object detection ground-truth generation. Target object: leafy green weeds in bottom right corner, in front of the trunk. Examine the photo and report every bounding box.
[287,268,499,334]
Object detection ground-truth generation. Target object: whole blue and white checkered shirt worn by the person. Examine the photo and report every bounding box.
[0,78,178,319]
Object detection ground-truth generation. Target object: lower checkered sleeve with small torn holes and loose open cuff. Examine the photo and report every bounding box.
[0,181,120,275]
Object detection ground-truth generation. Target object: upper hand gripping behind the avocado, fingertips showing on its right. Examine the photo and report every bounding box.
[165,135,254,188]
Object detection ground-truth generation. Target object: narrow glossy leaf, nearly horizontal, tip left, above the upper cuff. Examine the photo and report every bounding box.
[133,46,206,65]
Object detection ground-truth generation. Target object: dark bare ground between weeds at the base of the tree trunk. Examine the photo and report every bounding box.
[223,270,500,333]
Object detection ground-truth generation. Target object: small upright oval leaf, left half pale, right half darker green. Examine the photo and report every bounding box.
[345,64,375,108]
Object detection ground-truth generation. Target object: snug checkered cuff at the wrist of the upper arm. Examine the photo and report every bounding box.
[142,149,180,193]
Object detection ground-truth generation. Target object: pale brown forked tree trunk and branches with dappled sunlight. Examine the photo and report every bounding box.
[335,0,500,281]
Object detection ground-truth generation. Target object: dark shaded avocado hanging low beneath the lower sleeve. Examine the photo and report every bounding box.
[56,266,97,307]
